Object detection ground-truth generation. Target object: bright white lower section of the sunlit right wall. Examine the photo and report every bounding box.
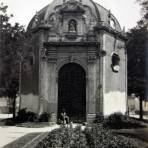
[104,91,126,115]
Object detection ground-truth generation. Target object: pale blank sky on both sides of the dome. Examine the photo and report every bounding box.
[0,0,141,31]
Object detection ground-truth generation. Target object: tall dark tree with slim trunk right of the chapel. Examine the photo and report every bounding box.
[126,0,148,119]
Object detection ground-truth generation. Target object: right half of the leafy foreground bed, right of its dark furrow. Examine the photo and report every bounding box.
[85,125,138,148]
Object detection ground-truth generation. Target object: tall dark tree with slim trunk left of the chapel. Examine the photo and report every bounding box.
[0,4,26,117]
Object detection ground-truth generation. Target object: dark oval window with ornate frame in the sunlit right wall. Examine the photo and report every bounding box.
[111,53,120,72]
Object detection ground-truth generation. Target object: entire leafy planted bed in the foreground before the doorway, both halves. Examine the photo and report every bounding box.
[36,124,138,148]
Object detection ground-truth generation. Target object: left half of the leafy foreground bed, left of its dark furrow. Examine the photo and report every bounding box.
[37,126,88,148]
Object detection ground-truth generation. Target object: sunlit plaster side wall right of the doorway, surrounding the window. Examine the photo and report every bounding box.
[103,34,127,115]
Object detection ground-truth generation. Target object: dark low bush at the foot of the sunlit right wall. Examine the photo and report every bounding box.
[103,113,146,129]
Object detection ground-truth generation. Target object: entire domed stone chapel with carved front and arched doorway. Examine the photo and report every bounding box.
[21,0,127,121]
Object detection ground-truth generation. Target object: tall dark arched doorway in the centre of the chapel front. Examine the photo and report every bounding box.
[58,63,86,121]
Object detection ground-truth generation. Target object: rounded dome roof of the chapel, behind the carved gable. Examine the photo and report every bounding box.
[27,0,122,32]
